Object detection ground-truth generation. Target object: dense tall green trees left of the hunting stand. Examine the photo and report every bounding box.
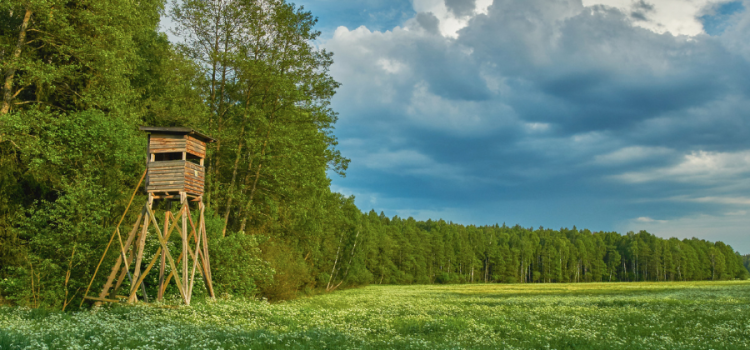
[0,0,173,306]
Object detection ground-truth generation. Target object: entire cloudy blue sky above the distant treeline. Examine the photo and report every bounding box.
[286,0,750,253]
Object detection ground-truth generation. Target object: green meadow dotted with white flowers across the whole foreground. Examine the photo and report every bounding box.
[0,282,750,349]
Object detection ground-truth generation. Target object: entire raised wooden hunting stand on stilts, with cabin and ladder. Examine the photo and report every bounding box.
[81,127,214,305]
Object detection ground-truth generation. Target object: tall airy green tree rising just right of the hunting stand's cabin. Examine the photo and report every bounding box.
[172,0,348,234]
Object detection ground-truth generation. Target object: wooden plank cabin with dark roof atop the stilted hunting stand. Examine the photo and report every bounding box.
[141,126,214,198]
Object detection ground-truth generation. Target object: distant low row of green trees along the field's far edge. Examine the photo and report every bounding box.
[314,219,750,286]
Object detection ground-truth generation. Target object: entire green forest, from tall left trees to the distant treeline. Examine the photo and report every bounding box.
[0,0,750,309]
